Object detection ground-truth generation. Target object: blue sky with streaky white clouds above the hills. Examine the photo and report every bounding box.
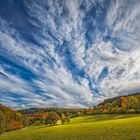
[0,0,140,109]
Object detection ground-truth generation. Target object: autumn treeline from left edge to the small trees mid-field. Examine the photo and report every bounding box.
[0,104,70,133]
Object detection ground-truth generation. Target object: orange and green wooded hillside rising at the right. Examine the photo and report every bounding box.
[85,94,140,115]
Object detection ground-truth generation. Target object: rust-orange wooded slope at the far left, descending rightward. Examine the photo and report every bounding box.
[0,104,23,133]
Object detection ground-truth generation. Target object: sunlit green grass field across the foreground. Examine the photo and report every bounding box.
[0,114,140,140]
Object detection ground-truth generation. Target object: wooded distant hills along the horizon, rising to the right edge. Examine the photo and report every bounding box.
[19,93,140,117]
